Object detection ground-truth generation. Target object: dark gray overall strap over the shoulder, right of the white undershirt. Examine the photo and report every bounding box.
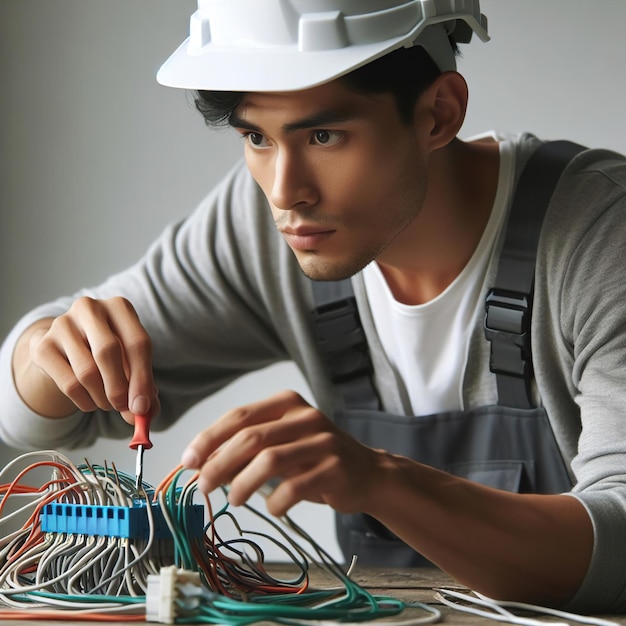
[485,141,584,409]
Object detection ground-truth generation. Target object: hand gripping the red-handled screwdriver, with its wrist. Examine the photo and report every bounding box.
[13,297,160,423]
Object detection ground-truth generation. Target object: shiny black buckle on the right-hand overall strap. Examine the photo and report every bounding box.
[485,289,532,379]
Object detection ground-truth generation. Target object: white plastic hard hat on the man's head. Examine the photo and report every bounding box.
[157,0,489,92]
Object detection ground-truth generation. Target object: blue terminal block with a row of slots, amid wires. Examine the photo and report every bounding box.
[40,502,204,539]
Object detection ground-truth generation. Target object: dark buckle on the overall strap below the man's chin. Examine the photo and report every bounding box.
[314,297,372,383]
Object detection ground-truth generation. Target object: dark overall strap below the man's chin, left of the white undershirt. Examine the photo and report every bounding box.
[312,278,380,410]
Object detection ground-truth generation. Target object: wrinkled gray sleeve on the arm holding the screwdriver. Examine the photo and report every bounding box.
[0,166,300,449]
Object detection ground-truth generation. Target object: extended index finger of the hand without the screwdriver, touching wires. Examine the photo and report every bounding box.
[182,391,309,468]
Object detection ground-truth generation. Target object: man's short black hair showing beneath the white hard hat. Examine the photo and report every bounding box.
[194,38,458,126]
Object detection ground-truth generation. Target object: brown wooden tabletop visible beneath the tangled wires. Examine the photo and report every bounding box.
[3,566,626,626]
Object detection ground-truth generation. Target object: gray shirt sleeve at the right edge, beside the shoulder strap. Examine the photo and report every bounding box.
[533,151,626,612]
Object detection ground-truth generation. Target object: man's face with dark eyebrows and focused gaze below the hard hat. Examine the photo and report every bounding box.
[231,81,426,280]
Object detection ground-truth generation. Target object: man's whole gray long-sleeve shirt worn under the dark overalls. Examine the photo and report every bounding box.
[0,135,626,611]
